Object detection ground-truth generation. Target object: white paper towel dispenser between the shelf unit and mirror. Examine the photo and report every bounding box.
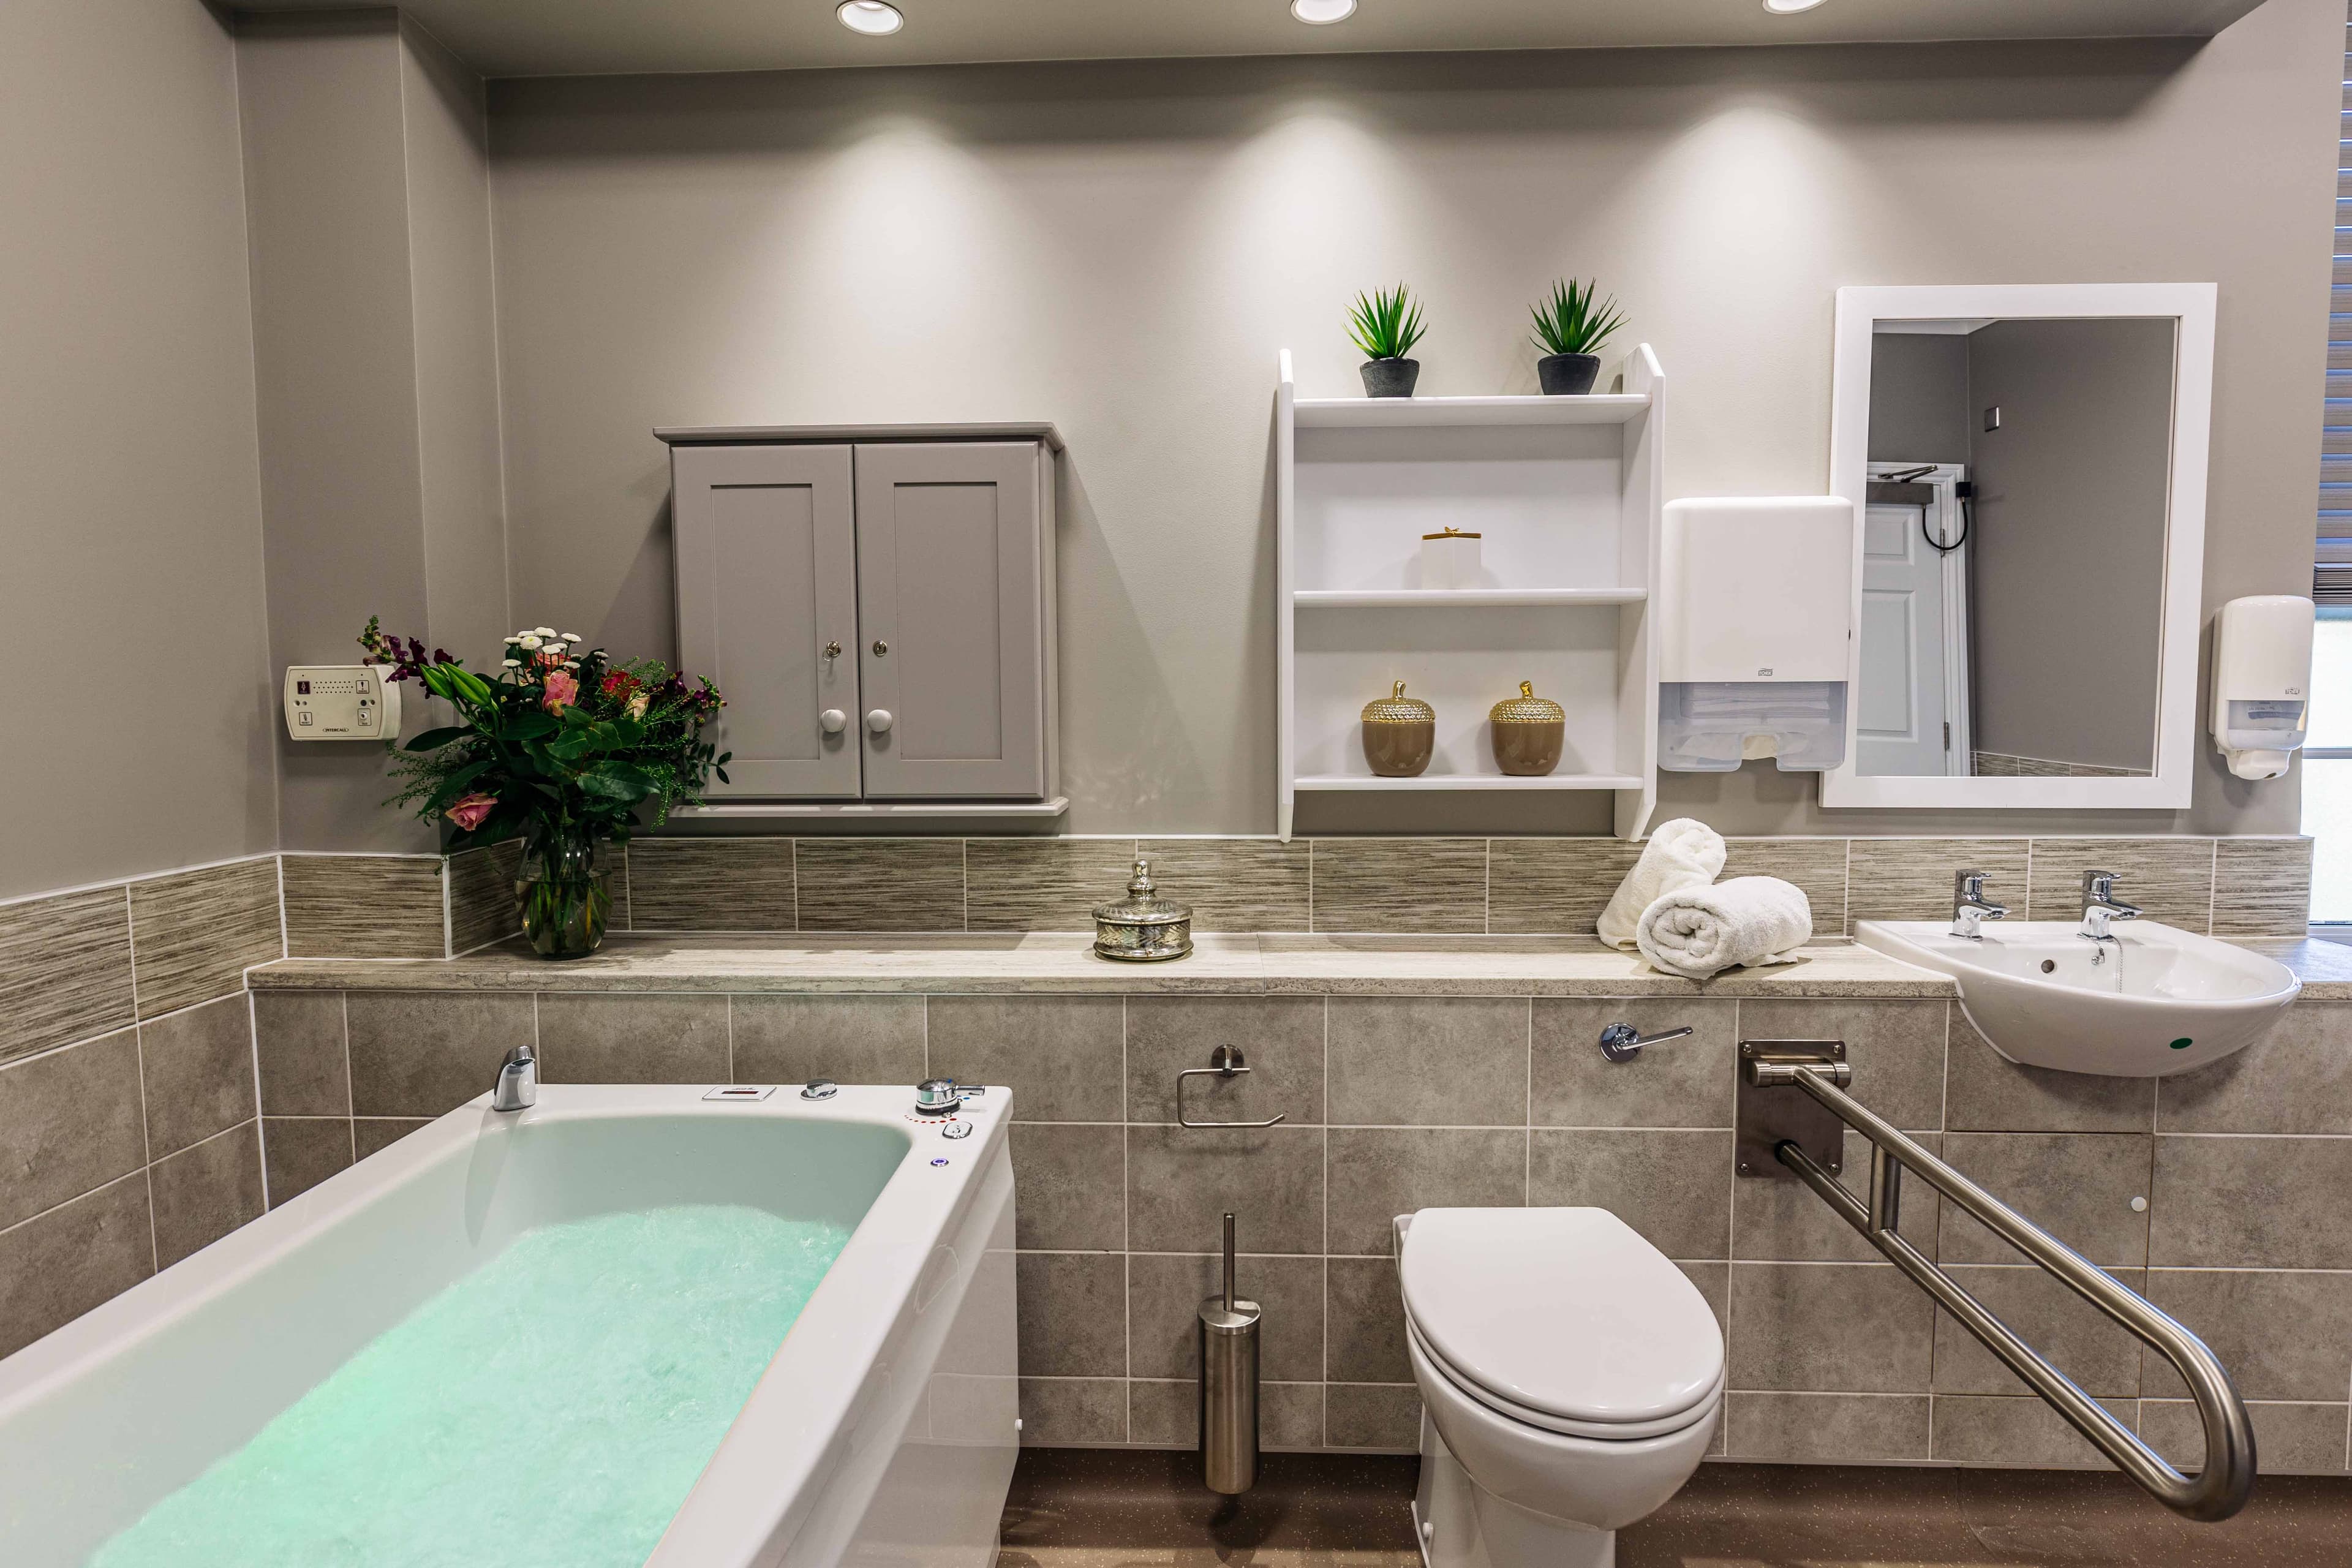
[1658,496,1853,774]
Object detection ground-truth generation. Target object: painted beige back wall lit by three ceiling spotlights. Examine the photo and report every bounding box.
[492,0,2343,832]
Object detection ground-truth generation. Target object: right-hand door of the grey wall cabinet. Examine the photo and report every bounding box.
[856,442,1044,799]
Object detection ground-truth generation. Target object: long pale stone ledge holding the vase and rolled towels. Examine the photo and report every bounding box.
[247,931,1956,997]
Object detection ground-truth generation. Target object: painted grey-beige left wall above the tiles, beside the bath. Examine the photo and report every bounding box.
[0,0,275,898]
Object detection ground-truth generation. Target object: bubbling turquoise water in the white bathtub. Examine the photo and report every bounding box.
[89,1206,849,1568]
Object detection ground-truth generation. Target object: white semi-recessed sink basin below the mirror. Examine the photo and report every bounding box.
[1853,919,2302,1079]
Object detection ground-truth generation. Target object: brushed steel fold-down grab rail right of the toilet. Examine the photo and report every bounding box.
[1743,1060,2256,1521]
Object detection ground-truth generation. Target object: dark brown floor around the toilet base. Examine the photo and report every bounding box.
[1000,1448,2352,1568]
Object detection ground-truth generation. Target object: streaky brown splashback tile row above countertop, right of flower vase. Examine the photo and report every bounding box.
[597,837,2312,952]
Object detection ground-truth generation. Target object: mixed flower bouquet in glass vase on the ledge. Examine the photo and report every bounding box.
[360,618,727,959]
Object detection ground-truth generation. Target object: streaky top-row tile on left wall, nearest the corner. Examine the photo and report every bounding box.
[132,856,285,1018]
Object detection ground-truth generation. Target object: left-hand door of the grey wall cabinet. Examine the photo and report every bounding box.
[670,447,859,799]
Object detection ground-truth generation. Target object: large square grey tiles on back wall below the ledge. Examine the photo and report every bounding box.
[243,992,2352,1472]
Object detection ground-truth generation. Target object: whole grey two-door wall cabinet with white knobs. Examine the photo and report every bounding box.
[658,426,1058,811]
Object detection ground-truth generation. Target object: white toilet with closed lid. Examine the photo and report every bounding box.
[1397,1208,1724,1568]
